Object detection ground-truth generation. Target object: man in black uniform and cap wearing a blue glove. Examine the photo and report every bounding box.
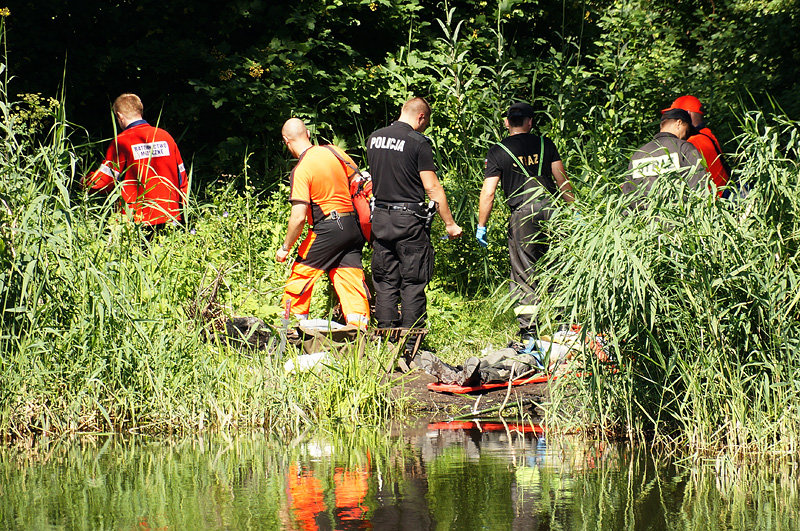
[475,102,574,341]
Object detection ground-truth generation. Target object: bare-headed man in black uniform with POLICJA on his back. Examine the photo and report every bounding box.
[367,98,461,328]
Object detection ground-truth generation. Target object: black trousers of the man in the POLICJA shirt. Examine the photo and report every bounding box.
[372,206,433,328]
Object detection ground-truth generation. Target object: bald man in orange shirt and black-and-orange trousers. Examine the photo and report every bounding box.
[275,118,369,327]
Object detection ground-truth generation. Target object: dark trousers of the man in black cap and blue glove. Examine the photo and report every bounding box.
[508,207,550,332]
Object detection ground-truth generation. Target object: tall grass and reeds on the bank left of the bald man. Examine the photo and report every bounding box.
[0,64,397,440]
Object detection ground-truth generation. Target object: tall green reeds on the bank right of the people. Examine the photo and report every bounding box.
[541,112,800,452]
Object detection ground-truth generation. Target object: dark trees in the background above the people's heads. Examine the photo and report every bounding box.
[6,0,800,187]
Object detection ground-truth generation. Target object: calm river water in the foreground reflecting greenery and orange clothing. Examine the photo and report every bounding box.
[0,422,800,530]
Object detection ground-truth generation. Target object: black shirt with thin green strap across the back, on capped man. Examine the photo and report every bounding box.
[483,133,561,210]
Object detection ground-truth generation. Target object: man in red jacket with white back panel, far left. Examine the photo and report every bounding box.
[83,94,189,235]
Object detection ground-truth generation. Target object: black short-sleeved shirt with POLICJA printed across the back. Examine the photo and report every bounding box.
[367,122,436,203]
